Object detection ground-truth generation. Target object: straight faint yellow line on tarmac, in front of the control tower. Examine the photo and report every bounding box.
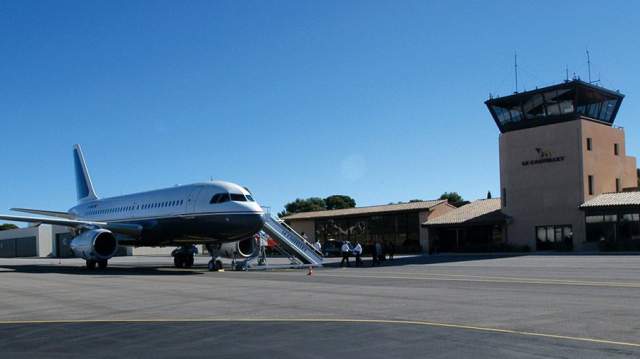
[296,272,640,288]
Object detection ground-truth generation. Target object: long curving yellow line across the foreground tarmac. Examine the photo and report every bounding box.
[0,318,640,348]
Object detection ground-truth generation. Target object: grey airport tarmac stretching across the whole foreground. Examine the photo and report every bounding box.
[0,255,640,358]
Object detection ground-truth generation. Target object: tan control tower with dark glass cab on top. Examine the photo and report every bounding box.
[485,80,637,251]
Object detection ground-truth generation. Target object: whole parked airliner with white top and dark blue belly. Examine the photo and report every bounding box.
[0,145,265,271]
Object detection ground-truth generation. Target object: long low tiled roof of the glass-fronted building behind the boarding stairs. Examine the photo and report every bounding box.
[282,199,447,220]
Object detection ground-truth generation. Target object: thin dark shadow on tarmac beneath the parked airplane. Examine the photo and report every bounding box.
[0,264,207,277]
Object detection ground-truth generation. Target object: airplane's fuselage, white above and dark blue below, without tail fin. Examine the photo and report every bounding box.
[69,181,264,246]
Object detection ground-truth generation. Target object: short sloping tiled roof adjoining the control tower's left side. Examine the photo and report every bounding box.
[422,198,507,226]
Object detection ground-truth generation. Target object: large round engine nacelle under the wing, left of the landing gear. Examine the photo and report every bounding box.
[70,229,118,261]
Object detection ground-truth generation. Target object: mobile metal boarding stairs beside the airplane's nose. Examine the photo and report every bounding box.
[237,217,322,270]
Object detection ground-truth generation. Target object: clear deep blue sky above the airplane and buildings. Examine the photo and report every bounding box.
[0,0,640,218]
